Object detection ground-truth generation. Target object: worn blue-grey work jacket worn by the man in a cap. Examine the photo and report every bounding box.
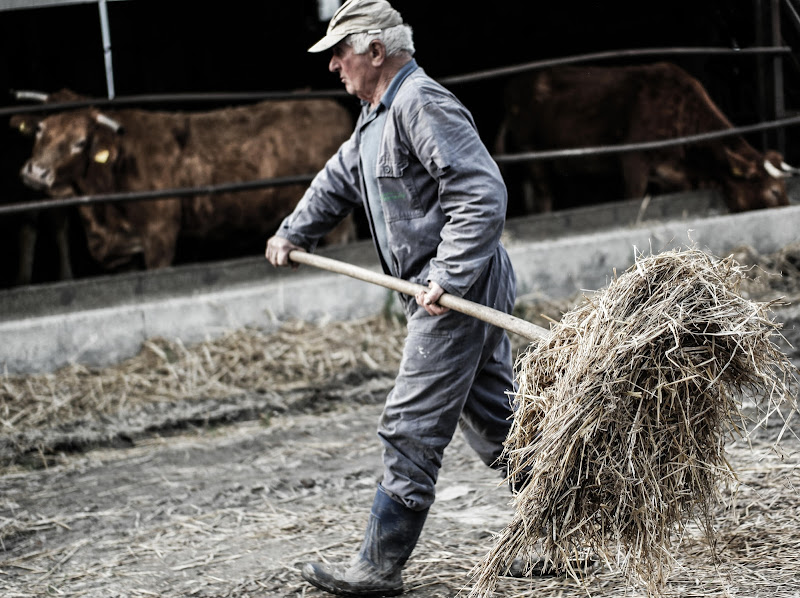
[277,64,507,297]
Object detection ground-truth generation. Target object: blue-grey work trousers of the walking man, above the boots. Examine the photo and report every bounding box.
[378,248,516,510]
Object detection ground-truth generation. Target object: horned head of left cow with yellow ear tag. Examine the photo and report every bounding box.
[20,109,123,197]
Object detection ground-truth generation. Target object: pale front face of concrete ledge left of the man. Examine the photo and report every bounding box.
[0,264,389,373]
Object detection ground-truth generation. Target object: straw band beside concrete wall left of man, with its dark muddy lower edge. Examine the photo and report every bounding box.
[0,316,404,472]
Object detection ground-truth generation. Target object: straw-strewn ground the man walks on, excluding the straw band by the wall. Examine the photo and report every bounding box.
[0,396,800,598]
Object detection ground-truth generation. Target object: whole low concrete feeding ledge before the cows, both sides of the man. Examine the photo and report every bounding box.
[0,197,800,373]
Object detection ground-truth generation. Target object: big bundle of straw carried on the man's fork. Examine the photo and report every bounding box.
[471,249,797,596]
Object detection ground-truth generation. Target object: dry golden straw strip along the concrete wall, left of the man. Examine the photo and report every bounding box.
[0,316,405,434]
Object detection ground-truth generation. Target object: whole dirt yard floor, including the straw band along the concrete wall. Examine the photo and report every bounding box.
[0,245,800,598]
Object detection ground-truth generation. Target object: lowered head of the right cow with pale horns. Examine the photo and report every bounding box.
[725,148,791,212]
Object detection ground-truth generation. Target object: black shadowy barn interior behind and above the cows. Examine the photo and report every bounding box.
[0,0,800,287]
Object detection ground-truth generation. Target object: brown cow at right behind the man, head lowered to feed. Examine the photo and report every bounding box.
[497,63,789,211]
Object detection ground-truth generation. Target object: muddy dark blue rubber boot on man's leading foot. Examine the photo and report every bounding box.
[302,485,428,596]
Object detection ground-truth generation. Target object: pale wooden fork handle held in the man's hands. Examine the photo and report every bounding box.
[289,250,550,341]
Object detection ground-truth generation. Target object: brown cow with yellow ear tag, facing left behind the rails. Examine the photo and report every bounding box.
[14,91,353,269]
